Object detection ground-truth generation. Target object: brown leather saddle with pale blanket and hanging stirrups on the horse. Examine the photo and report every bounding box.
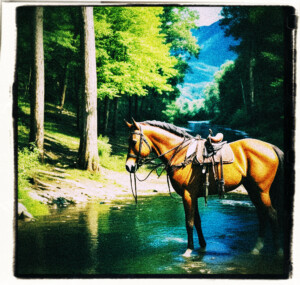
[186,130,234,205]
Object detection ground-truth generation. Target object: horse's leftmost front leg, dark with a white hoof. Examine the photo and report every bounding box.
[182,190,197,257]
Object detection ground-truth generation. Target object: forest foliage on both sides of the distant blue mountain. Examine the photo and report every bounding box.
[17,6,285,162]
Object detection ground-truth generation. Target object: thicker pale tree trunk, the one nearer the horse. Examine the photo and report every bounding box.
[78,7,99,171]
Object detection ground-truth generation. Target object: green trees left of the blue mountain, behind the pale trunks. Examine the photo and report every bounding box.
[17,6,199,139]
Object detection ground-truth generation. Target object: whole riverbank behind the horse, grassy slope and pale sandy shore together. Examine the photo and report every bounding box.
[18,104,245,220]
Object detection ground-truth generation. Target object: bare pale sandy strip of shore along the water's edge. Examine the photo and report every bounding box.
[25,168,247,211]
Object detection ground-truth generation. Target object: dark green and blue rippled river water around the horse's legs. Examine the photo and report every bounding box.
[16,194,286,277]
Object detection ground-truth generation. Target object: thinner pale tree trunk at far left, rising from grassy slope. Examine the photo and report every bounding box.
[30,7,45,160]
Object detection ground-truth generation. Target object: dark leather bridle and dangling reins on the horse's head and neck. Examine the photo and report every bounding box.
[127,125,190,204]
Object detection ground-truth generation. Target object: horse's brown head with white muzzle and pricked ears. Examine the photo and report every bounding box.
[125,120,152,173]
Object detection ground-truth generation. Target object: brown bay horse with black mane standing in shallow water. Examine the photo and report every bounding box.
[125,119,284,257]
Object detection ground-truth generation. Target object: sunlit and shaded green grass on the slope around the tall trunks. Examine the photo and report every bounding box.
[18,98,127,216]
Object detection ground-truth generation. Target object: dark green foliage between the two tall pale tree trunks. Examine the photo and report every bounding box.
[44,7,80,110]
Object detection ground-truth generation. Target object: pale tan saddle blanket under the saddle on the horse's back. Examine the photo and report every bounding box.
[186,139,234,165]
